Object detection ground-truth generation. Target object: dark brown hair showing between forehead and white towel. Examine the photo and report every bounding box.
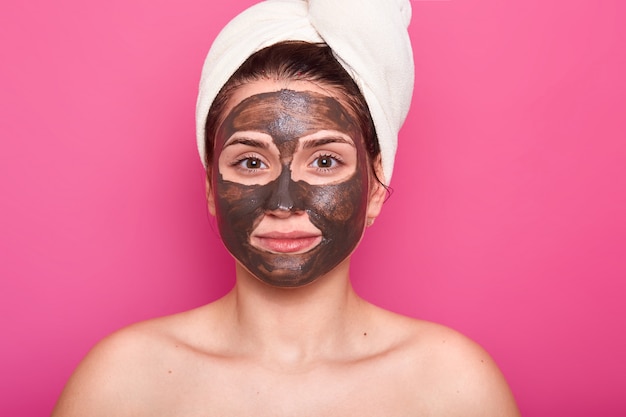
[205,41,380,179]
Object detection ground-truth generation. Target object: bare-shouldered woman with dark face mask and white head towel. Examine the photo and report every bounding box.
[53,0,518,417]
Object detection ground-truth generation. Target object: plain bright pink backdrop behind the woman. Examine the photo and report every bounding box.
[0,0,626,417]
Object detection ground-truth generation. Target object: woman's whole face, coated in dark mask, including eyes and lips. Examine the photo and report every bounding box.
[209,80,380,287]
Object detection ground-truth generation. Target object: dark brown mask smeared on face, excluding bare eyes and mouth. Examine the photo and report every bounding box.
[212,90,368,287]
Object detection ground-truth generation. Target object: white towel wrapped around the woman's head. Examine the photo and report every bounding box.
[196,0,414,184]
